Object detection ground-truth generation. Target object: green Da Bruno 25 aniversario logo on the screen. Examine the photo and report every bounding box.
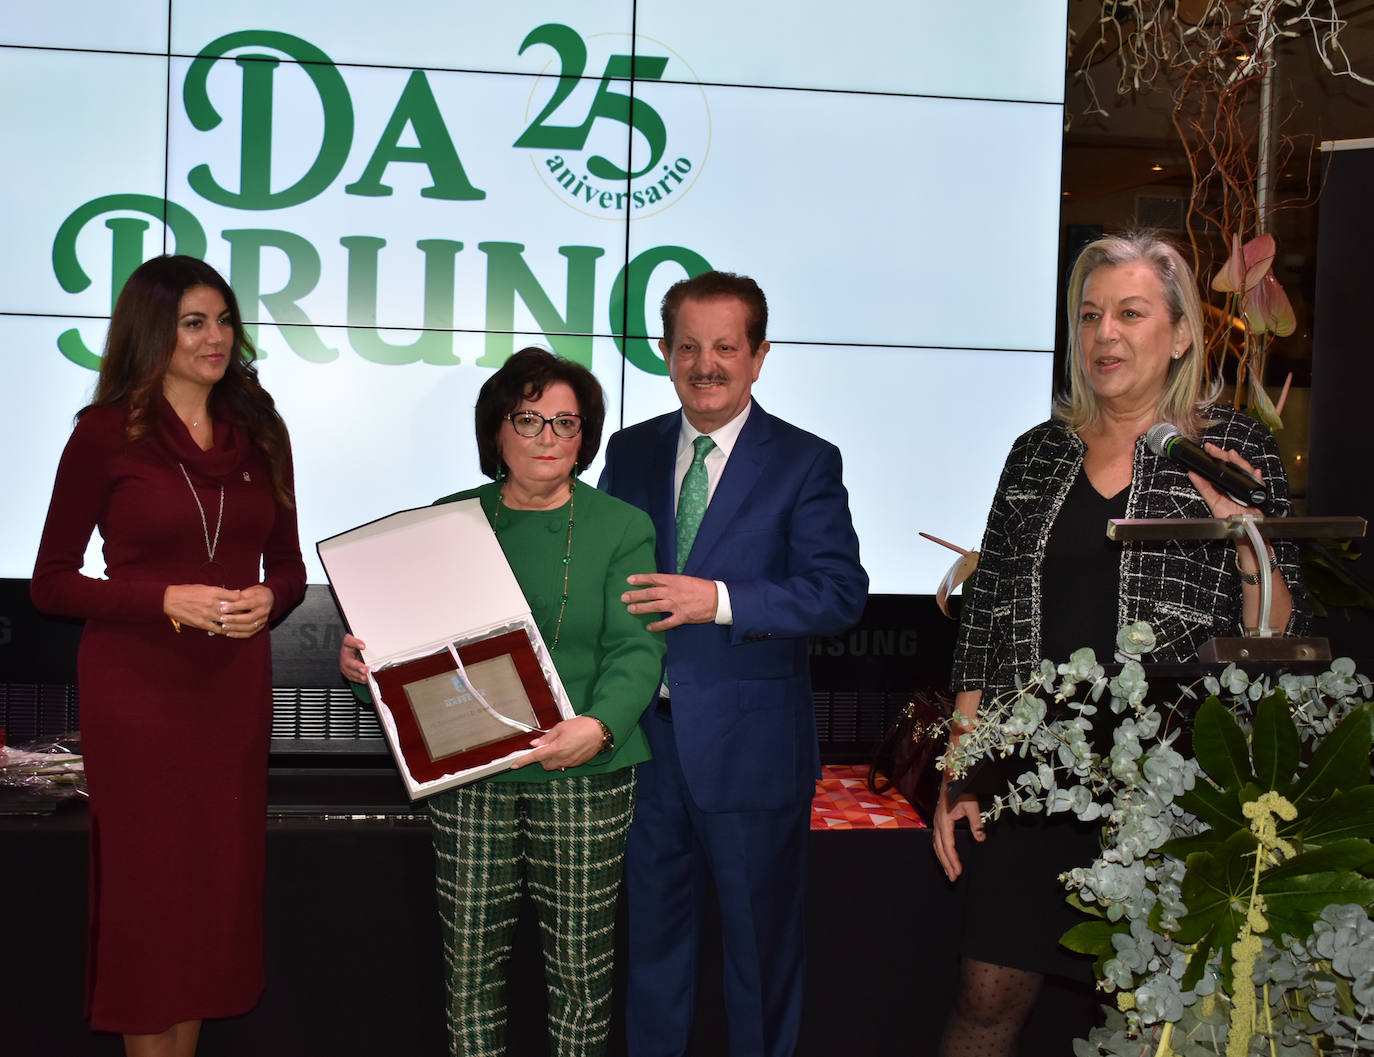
[52,23,710,374]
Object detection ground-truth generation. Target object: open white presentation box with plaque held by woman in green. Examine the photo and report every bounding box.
[316,499,573,800]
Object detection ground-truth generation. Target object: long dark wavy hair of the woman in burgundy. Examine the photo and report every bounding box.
[77,256,293,506]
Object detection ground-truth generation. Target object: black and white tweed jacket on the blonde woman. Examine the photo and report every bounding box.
[952,405,1309,694]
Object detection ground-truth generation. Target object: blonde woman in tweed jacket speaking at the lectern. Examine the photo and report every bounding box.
[934,235,1308,1057]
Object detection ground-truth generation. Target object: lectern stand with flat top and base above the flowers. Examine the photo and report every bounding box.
[1107,514,1366,664]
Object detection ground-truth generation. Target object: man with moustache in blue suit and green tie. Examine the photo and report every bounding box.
[600,272,868,1057]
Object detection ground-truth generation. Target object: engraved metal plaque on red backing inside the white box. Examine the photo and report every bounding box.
[374,630,562,782]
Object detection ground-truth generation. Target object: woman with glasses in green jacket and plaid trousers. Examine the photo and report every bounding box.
[339,348,664,1057]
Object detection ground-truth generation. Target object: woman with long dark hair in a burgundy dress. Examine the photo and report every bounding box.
[32,257,305,1057]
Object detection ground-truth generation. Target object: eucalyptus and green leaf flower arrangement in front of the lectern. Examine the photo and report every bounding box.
[944,623,1374,1057]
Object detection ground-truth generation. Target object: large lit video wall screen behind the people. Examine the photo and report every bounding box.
[0,0,1066,594]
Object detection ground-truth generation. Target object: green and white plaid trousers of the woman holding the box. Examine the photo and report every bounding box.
[429,767,635,1057]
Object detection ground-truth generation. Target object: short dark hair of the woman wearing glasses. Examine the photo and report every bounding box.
[473,345,606,478]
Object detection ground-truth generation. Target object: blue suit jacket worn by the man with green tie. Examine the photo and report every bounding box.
[600,401,868,811]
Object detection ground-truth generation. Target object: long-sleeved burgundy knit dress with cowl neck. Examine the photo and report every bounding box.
[32,399,305,1034]
